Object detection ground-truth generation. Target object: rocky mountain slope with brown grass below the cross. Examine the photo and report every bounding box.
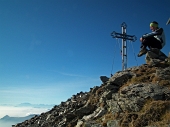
[13,59,170,127]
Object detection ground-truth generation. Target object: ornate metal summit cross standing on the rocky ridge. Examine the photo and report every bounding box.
[111,22,137,71]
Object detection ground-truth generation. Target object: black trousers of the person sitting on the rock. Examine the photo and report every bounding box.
[141,37,162,49]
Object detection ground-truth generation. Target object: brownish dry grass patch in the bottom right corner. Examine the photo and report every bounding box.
[120,100,170,127]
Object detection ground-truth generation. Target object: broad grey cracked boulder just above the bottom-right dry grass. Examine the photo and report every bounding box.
[106,84,170,113]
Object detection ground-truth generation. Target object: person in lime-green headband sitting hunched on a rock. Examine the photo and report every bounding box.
[138,21,165,57]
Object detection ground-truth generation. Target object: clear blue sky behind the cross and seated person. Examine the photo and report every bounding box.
[0,0,170,104]
